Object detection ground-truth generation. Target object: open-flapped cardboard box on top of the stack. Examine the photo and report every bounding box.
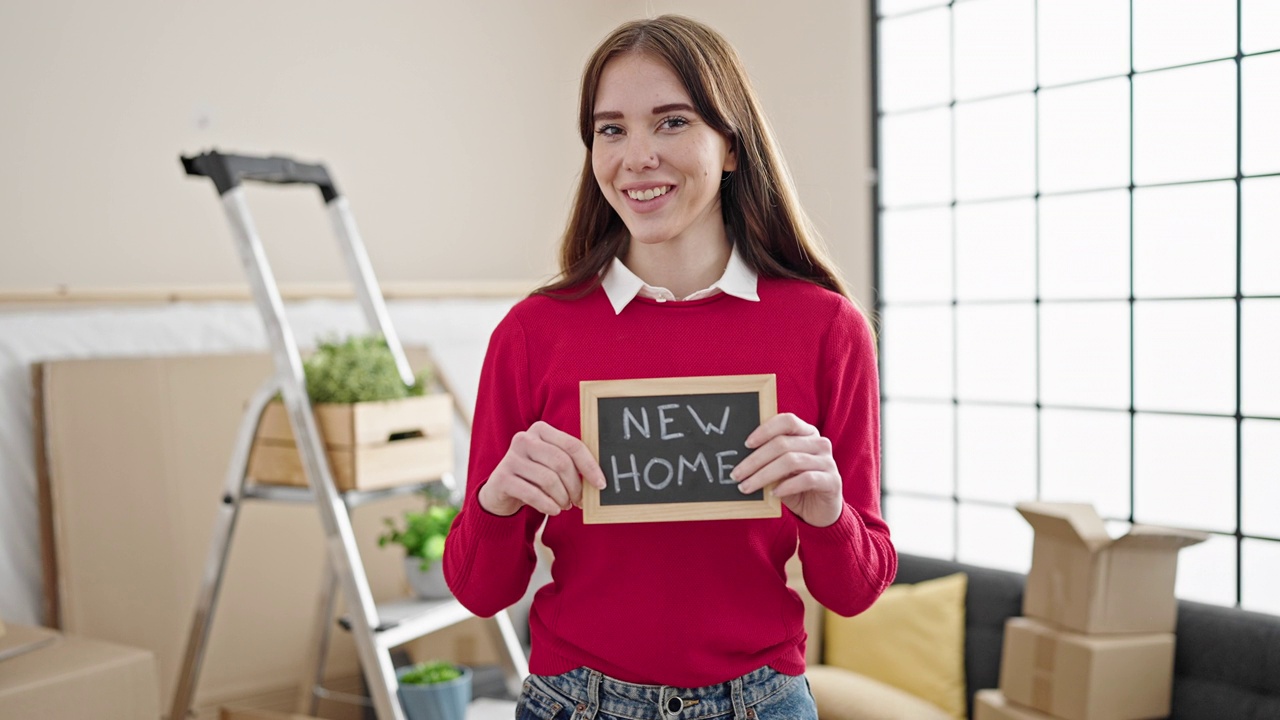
[1018,502,1208,633]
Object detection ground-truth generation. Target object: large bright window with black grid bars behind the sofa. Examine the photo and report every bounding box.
[874,0,1280,614]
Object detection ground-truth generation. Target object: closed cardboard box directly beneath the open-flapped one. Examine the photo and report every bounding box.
[1000,609,1174,720]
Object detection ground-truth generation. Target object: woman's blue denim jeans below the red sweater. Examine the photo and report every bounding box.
[516,667,818,720]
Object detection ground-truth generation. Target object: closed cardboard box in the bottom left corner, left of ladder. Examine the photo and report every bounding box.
[0,625,160,720]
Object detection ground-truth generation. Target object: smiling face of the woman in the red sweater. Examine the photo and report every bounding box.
[591,53,737,245]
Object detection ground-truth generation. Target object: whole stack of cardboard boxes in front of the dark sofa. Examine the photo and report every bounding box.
[974,502,1207,720]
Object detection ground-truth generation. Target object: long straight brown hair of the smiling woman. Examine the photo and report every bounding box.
[536,15,852,300]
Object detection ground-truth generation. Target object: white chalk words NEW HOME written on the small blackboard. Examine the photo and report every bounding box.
[609,402,739,493]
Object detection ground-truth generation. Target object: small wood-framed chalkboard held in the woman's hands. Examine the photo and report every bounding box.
[580,375,782,524]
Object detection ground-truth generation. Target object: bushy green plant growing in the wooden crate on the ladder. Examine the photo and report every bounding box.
[302,336,434,404]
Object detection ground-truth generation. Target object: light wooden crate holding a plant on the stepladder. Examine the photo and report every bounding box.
[248,395,453,491]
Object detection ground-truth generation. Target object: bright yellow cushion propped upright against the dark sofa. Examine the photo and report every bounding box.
[823,573,968,720]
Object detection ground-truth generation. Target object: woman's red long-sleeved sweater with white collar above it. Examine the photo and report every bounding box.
[444,278,897,688]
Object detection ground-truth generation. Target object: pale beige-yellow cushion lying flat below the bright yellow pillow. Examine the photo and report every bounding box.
[804,665,951,720]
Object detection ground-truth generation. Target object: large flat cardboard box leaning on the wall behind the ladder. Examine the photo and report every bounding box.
[37,350,442,720]
